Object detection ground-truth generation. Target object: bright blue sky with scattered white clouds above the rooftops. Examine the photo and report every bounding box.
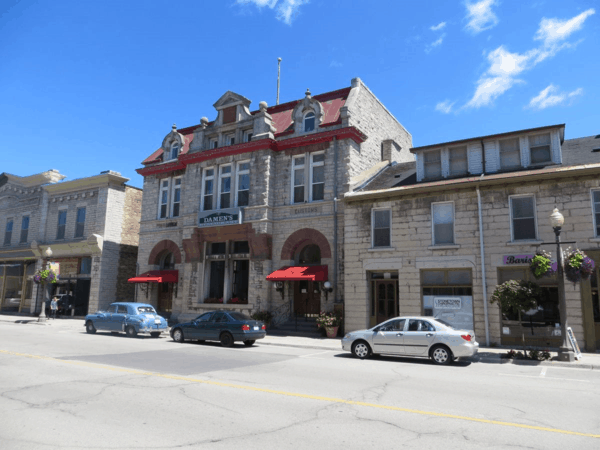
[0,0,600,187]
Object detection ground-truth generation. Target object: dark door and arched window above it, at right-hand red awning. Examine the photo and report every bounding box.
[293,244,321,317]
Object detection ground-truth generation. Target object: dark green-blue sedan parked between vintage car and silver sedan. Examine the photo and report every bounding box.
[171,311,267,347]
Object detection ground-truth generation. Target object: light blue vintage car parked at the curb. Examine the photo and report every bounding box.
[85,302,168,338]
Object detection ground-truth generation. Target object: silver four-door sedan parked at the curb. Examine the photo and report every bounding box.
[342,317,479,364]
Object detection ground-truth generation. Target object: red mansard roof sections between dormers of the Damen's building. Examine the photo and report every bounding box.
[142,87,351,165]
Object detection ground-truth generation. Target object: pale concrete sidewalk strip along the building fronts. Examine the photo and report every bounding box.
[0,314,600,370]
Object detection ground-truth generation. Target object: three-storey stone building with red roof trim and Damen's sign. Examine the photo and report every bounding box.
[130,78,414,321]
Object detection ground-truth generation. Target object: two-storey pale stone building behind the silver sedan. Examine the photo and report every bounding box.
[344,125,600,351]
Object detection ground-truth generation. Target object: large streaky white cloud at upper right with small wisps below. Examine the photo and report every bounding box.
[464,9,595,109]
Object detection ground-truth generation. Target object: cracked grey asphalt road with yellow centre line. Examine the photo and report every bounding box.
[0,322,600,450]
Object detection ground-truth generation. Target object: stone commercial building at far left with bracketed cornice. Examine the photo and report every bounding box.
[0,170,142,316]
